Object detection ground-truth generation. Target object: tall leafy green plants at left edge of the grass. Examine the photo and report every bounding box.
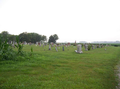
[0,36,33,60]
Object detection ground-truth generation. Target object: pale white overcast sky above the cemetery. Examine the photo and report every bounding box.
[0,0,120,42]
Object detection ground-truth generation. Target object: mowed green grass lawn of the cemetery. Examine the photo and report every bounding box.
[0,45,120,89]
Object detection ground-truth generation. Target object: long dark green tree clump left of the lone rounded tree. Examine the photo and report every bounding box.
[0,31,47,43]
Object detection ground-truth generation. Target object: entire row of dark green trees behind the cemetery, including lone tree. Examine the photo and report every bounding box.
[0,31,58,43]
